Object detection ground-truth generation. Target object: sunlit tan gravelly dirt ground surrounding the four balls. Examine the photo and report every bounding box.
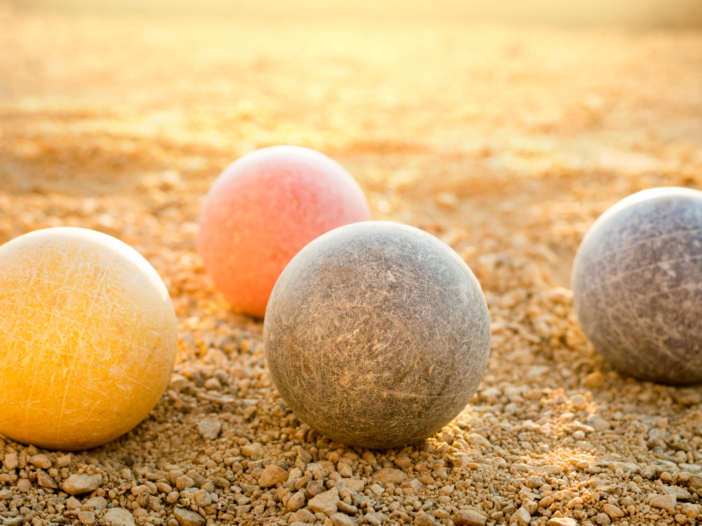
[0,10,702,526]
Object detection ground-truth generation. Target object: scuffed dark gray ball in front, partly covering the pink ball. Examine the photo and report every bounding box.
[264,221,490,449]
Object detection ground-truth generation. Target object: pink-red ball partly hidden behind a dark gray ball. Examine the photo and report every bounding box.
[198,146,371,318]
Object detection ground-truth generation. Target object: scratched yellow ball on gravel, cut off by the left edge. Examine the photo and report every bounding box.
[0,228,178,450]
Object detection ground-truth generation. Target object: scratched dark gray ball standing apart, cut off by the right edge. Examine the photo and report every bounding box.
[572,188,702,384]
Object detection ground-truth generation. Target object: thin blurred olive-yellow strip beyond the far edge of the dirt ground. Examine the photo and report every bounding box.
[4,0,702,27]
